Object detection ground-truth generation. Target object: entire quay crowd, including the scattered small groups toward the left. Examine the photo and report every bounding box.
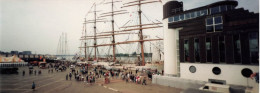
[23,62,160,90]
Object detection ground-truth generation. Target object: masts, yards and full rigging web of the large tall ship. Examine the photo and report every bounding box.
[77,0,163,70]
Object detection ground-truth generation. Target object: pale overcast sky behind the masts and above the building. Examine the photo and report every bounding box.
[0,0,259,54]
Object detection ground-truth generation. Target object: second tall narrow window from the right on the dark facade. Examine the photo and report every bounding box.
[233,35,241,63]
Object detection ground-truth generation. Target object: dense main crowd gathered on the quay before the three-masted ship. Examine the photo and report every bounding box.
[65,65,157,85]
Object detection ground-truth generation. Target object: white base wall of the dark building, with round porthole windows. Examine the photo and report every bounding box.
[180,63,259,86]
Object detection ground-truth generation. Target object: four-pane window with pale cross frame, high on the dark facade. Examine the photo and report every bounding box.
[206,16,223,32]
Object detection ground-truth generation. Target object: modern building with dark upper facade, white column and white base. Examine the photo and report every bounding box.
[163,0,259,86]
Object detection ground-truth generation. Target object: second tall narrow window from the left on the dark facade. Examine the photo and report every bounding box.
[194,38,200,62]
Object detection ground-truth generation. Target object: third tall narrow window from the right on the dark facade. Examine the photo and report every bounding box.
[218,36,226,62]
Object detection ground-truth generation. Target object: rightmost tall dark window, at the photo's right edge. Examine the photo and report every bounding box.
[249,32,259,63]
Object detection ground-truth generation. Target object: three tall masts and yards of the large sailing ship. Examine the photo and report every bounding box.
[79,0,163,69]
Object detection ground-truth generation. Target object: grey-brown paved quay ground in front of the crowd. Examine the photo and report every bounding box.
[0,67,182,93]
